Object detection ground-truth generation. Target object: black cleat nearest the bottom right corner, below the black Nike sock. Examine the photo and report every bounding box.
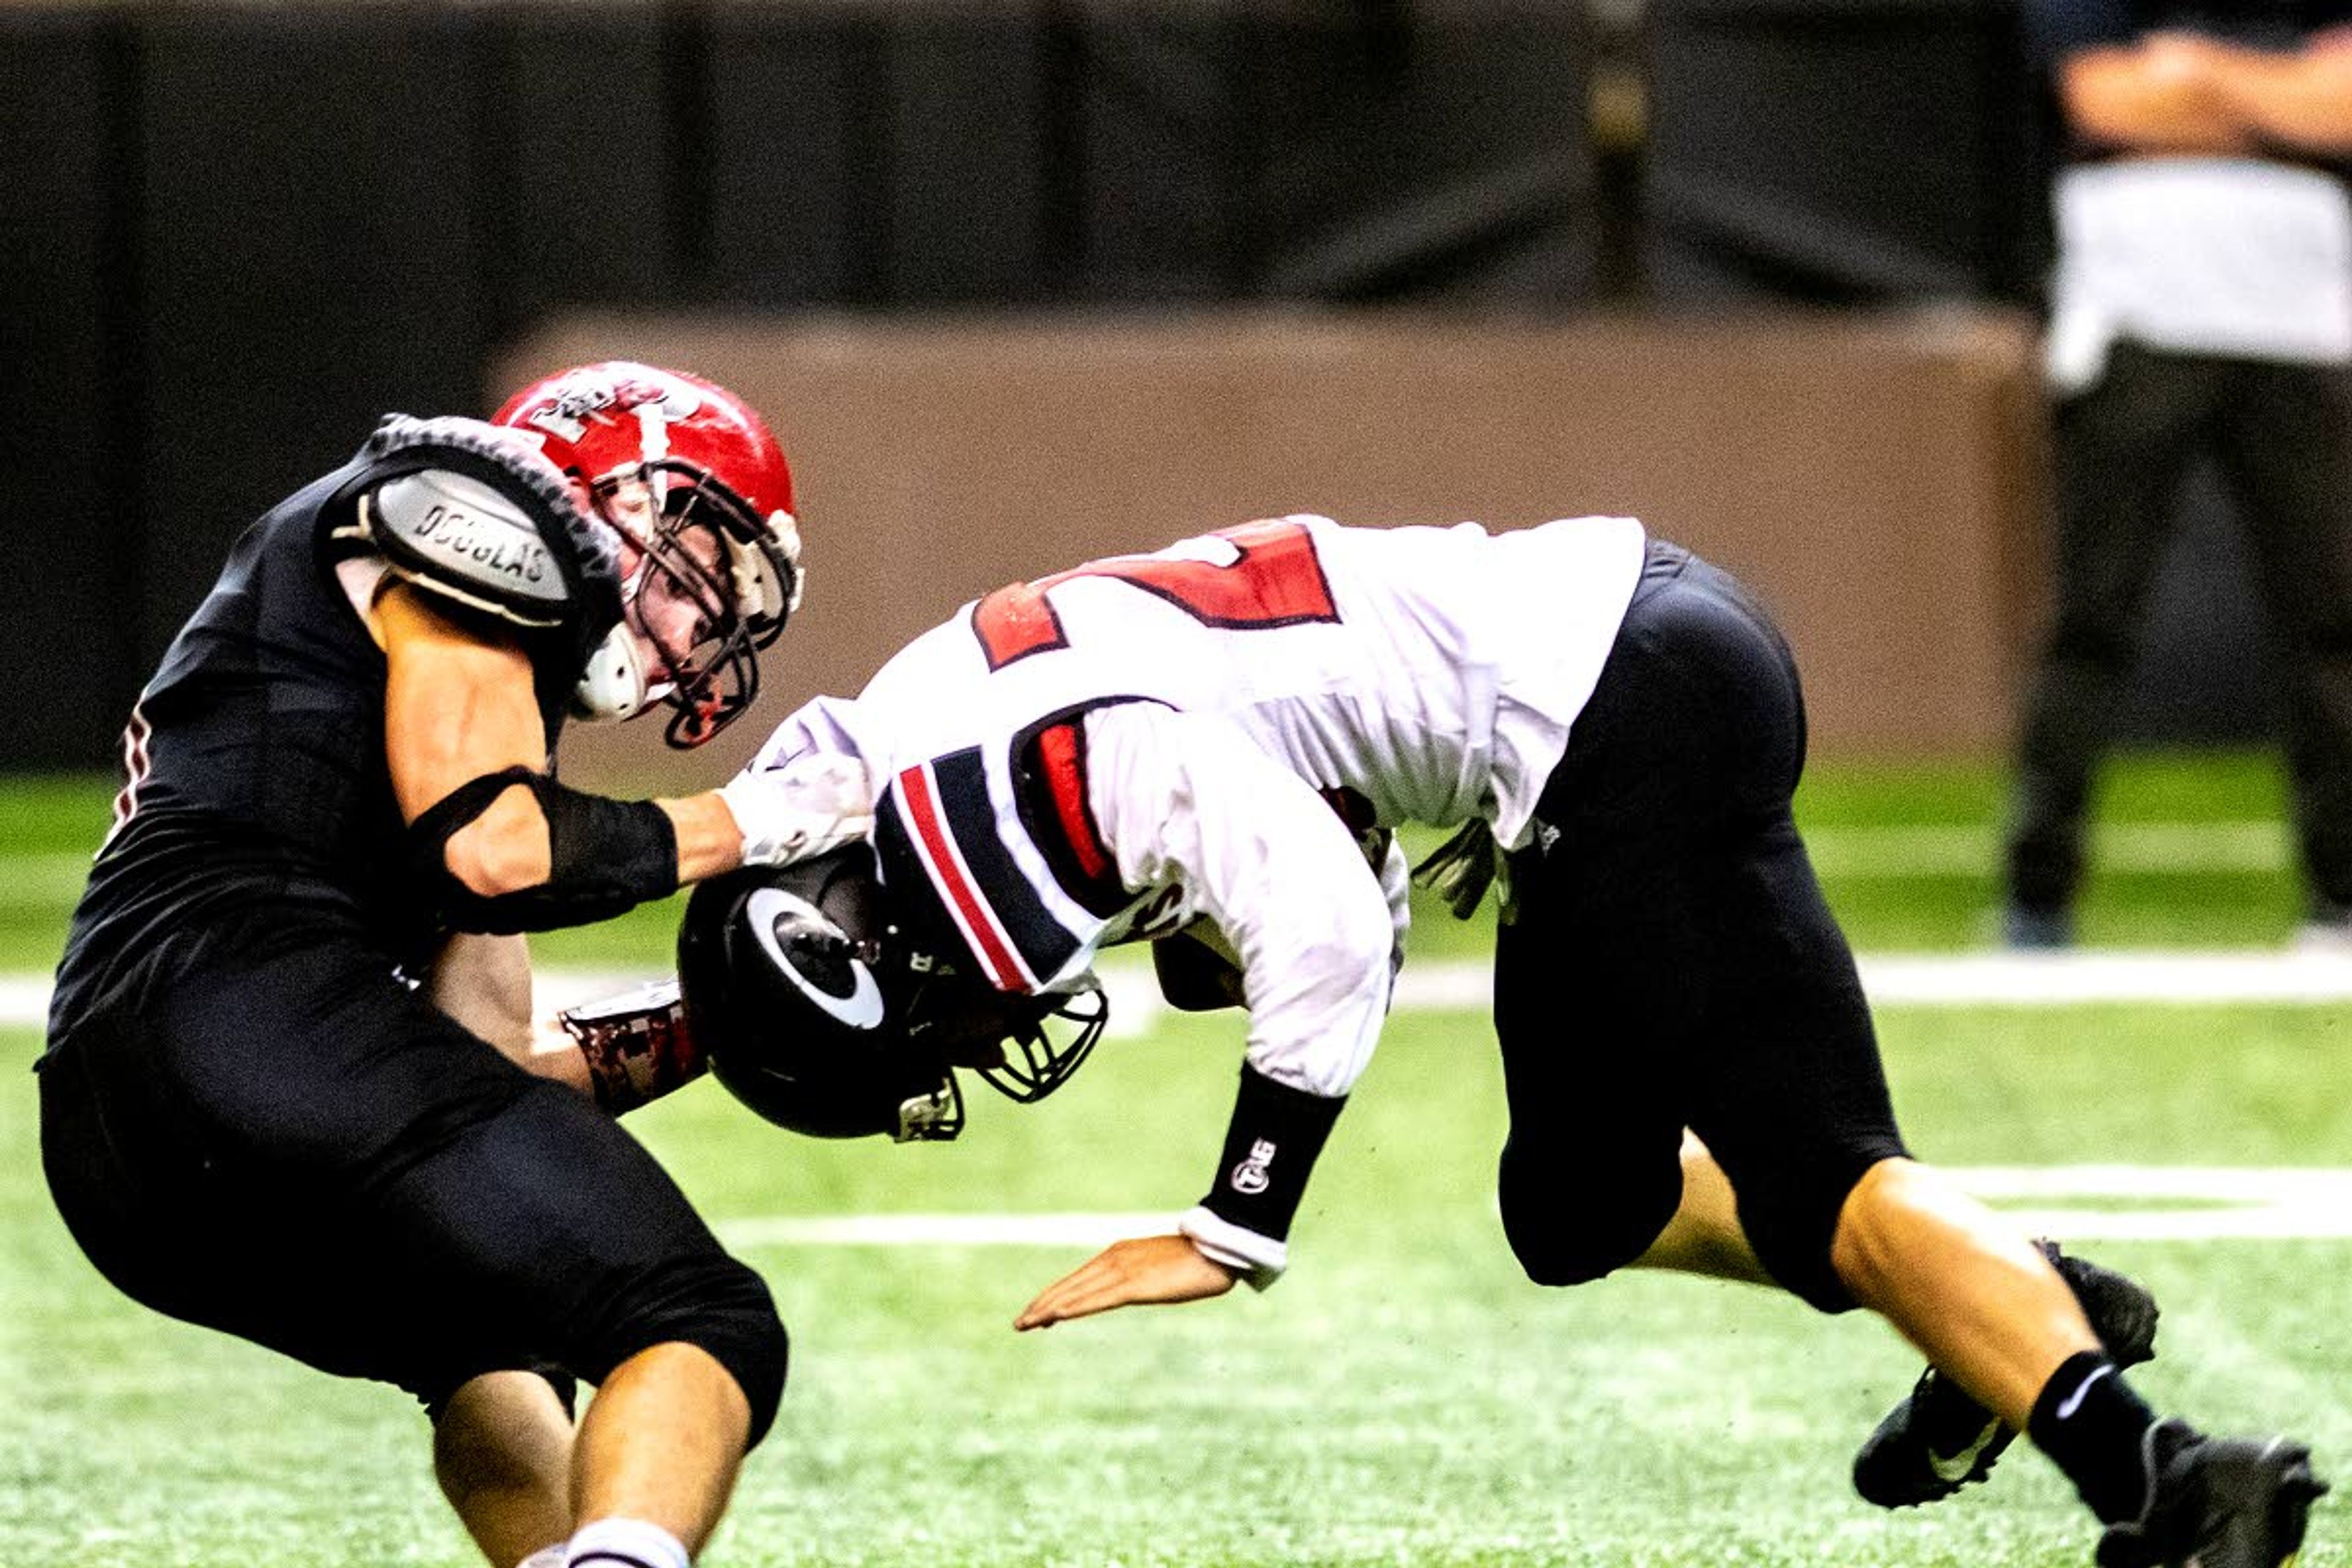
[2098,1420,2329,1568]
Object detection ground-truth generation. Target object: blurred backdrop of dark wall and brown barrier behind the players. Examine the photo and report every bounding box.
[0,0,2260,766]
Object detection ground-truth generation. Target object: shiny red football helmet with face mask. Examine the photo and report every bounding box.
[492,360,800,748]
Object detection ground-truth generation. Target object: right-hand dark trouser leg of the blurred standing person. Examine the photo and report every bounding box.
[2220,362,2352,940]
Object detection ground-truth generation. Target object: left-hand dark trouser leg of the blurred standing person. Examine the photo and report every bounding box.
[2004,343,2211,945]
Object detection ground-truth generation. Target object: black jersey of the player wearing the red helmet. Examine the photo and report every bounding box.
[50,451,579,1041]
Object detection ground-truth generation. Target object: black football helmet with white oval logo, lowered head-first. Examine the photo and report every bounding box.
[677,842,1108,1142]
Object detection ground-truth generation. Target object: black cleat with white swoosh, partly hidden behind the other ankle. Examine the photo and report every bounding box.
[1853,1242,2157,1509]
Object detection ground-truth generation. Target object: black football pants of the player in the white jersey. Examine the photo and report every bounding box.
[1496,543,1903,1310]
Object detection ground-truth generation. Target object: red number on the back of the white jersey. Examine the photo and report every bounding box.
[971,519,1338,670]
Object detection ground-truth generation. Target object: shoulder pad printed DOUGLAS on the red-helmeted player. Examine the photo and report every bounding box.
[355,414,621,646]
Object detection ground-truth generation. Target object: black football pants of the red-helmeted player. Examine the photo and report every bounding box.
[40,917,786,1436]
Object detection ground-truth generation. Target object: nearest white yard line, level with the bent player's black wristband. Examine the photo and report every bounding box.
[717,1166,2352,1248]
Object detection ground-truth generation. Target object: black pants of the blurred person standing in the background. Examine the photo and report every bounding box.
[2008,343,2352,912]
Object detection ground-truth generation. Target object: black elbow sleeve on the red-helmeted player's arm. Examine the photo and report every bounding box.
[409,766,677,936]
